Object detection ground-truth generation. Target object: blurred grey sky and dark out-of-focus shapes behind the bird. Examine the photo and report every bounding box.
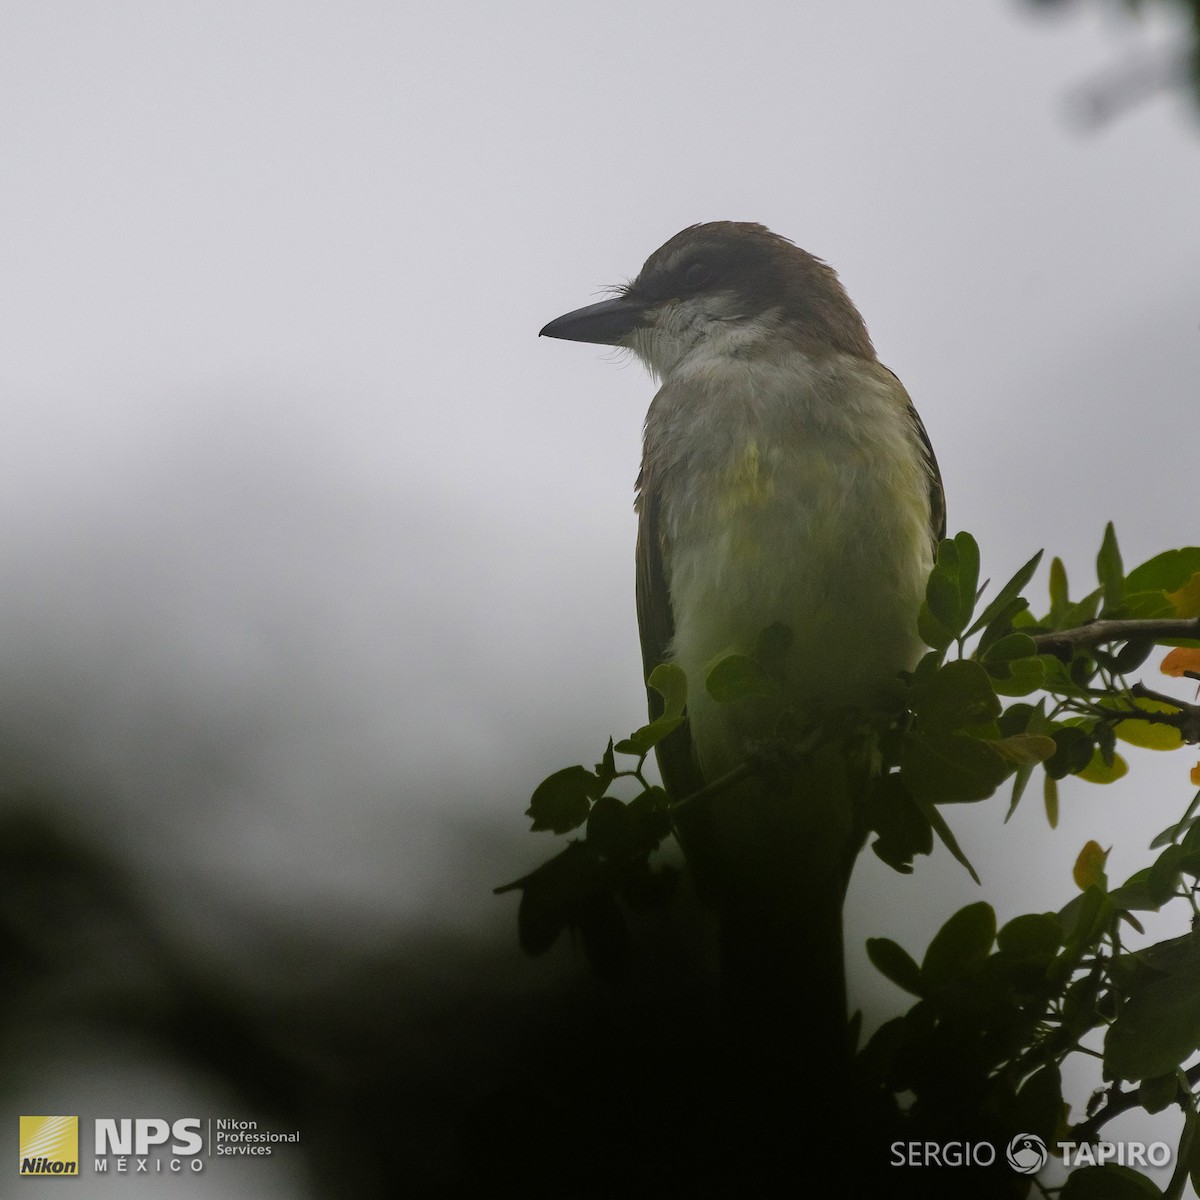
[0,0,1200,1200]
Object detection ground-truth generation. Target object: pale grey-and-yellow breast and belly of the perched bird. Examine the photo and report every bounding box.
[646,350,931,775]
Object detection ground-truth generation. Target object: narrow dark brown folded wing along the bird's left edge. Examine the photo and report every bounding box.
[637,463,704,800]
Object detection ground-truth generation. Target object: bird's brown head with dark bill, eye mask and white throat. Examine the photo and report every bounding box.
[541,221,875,377]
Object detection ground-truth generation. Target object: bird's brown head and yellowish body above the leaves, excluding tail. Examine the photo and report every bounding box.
[541,221,946,798]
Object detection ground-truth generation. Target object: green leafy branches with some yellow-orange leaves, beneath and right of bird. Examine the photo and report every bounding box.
[497,526,1200,1200]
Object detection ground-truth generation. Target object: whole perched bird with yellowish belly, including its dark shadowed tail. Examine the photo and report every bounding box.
[541,221,946,1128]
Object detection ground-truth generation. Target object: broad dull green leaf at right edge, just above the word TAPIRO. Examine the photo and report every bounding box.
[1104,974,1200,1080]
